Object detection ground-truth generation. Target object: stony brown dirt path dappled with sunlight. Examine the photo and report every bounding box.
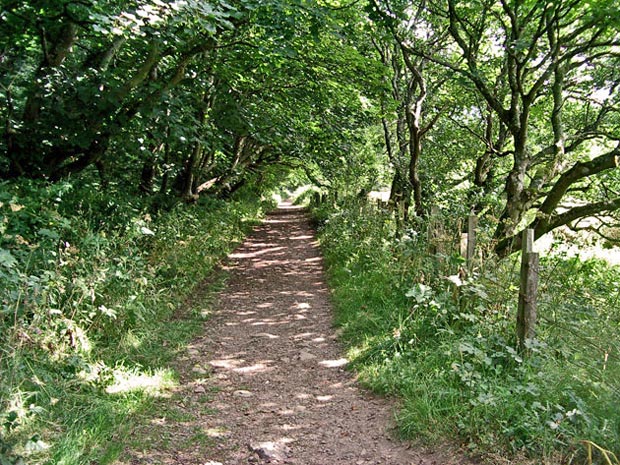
[120,204,464,465]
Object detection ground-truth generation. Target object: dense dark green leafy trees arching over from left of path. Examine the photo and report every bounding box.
[0,0,374,203]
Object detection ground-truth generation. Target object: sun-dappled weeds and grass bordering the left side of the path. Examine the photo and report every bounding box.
[0,181,268,465]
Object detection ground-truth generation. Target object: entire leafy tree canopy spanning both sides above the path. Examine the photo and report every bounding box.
[0,0,620,250]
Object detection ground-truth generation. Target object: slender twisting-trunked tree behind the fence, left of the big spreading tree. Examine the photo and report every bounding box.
[370,0,447,221]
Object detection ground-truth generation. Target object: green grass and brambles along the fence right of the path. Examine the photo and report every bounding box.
[314,199,620,464]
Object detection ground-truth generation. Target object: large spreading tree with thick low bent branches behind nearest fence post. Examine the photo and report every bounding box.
[376,0,620,255]
